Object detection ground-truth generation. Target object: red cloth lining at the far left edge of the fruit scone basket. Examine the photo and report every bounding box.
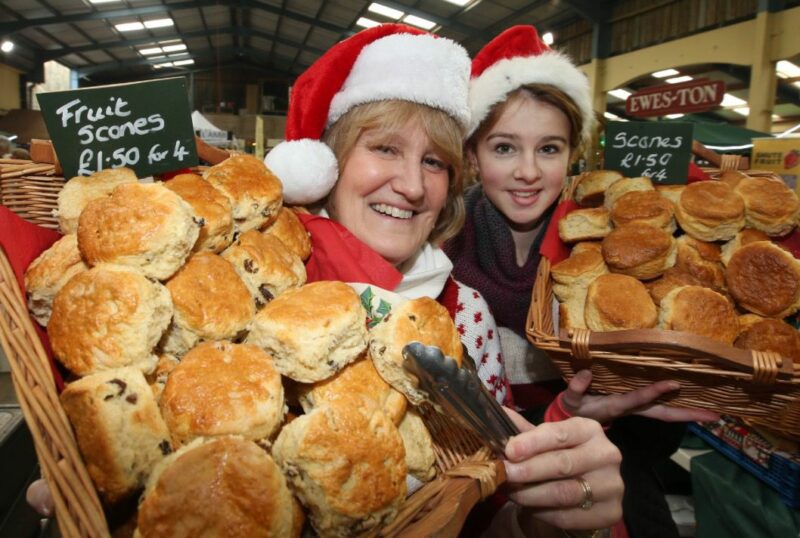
[0,205,64,392]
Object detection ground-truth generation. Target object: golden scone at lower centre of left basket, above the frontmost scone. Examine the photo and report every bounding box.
[159,342,286,446]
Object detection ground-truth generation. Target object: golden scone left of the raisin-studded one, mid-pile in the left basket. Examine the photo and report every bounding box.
[165,252,256,338]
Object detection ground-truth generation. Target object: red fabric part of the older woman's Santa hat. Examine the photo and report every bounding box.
[286,24,428,140]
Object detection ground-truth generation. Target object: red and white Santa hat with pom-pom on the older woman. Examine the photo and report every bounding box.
[264,24,470,204]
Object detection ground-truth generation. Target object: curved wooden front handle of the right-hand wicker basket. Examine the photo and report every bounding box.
[559,329,794,384]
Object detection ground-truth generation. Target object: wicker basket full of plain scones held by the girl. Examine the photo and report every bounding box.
[527,162,800,437]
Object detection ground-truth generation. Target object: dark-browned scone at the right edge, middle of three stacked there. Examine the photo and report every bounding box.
[725,241,800,317]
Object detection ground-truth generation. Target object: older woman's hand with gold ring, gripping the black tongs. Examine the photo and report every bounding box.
[505,410,624,529]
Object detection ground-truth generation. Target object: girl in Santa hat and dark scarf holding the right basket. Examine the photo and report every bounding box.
[445,26,716,536]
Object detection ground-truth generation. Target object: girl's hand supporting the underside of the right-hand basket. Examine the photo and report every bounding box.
[561,370,719,423]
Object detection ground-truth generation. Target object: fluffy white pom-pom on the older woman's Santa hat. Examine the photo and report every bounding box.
[264,139,339,205]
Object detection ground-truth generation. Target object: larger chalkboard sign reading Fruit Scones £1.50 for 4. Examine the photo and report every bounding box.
[38,78,198,178]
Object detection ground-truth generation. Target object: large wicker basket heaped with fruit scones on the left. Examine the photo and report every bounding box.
[0,156,504,538]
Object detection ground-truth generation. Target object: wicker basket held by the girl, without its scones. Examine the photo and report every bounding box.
[526,158,800,438]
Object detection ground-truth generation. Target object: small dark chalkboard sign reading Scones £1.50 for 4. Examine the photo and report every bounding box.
[604,121,693,184]
